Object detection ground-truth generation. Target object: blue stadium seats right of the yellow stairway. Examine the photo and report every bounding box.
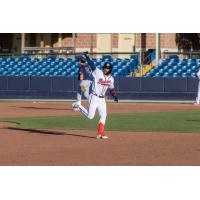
[145,58,200,77]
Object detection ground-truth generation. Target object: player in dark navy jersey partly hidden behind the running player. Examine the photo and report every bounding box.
[72,55,91,106]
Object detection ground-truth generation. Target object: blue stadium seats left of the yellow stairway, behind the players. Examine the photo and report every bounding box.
[0,54,138,77]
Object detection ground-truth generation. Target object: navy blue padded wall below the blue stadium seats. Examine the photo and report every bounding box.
[0,77,198,100]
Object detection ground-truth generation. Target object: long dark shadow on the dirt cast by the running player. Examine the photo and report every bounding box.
[7,127,96,139]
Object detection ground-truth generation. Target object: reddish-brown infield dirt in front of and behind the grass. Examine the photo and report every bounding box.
[0,102,200,166]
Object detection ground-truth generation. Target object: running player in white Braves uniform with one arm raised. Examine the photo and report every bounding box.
[73,53,118,139]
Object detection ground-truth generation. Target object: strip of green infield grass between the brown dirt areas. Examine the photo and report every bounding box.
[0,111,200,133]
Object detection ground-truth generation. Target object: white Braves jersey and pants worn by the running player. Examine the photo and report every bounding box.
[79,68,114,124]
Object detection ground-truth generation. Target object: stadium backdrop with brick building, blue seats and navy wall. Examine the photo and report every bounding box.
[0,33,200,99]
